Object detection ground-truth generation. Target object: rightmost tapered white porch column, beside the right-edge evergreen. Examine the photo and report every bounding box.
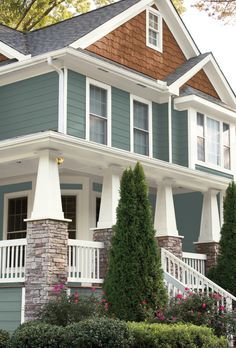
[198,189,220,243]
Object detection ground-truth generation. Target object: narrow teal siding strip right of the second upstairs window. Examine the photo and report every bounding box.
[152,103,169,162]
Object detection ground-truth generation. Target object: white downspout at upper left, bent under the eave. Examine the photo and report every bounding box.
[47,57,66,134]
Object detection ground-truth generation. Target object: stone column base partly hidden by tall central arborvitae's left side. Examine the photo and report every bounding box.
[93,228,113,279]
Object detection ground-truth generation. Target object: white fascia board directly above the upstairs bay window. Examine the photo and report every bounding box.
[174,95,236,122]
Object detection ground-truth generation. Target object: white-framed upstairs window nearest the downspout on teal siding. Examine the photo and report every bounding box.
[86,81,111,145]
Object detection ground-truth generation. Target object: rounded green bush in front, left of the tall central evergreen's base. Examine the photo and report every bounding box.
[63,317,133,348]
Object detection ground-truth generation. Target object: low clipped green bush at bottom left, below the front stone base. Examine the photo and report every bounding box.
[10,322,64,348]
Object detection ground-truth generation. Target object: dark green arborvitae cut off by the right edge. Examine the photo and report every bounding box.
[208,182,236,296]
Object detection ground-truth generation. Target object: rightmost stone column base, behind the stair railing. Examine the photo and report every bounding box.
[195,242,219,273]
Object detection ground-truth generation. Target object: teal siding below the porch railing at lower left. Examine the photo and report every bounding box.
[0,287,22,332]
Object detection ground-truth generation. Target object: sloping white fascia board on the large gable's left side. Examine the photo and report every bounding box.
[70,0,154,49]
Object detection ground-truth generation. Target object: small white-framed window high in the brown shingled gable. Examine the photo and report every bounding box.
[146,8,162,52]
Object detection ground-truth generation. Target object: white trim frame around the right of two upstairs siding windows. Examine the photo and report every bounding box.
[130,94,153,157]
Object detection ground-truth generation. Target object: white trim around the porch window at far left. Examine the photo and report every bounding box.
[3,191,32,240]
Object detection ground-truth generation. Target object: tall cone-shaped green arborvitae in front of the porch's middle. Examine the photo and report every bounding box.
[104,164,167,321]
